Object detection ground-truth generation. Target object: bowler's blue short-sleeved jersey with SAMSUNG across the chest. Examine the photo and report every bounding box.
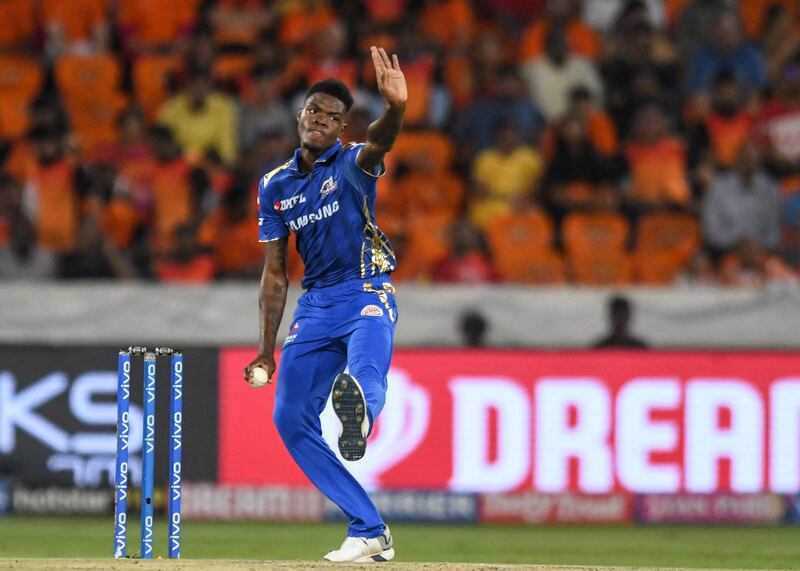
[258,141,397,289]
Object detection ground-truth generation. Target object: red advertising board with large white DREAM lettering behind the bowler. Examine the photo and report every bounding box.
[218,348,800,494]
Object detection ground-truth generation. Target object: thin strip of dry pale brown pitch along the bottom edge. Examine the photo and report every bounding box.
[0,559,768,571]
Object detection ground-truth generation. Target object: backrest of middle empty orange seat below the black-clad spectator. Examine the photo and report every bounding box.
[561,212,630,256]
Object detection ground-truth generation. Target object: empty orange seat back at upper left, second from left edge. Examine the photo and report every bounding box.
[55,54,121,104]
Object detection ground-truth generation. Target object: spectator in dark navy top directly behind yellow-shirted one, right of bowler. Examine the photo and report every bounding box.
[453,65,544,159]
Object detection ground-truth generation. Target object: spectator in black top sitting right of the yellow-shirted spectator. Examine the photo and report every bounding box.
[542,114,619,220]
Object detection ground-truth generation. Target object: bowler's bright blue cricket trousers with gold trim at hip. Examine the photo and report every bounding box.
[273,276,397,537]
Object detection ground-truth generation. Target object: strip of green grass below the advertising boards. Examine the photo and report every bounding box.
[0,517,800,569]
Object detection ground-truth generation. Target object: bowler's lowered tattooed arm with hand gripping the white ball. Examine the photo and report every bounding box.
[244,238,289,382]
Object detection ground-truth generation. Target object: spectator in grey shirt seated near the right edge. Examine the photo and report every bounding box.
[702,142,781,257]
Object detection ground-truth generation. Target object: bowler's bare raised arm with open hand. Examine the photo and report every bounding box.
[356,46,408,172]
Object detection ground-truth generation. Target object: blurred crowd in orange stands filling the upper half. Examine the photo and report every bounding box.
[0,0,800,287]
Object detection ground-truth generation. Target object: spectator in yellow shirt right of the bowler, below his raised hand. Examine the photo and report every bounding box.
[470,123,544,229]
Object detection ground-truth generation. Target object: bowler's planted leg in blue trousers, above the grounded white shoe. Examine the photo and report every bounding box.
[273,338,384,537]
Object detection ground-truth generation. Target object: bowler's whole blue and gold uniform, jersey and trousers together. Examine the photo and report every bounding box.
[258,142,397,538]
